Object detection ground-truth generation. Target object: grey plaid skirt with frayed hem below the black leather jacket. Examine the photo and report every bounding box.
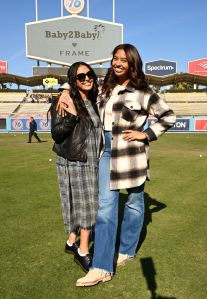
[56,156,98,233]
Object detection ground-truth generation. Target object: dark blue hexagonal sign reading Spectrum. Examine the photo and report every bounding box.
[145,60,177,77]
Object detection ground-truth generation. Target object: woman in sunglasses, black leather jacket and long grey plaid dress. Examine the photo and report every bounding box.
[50,62,102,271]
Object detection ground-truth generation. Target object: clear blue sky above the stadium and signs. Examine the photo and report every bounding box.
[0,0,207,77]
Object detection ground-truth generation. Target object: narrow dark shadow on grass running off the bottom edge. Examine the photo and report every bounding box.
[140,257,176,299]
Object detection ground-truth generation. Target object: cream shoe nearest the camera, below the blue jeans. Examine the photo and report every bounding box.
[76,268,112,287]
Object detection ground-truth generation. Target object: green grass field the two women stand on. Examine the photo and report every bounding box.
[0,133,207,299]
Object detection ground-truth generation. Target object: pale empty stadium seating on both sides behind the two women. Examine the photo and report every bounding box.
[0,91,207,117]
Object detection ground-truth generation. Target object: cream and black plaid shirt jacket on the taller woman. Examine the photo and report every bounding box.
[97,85,176,190]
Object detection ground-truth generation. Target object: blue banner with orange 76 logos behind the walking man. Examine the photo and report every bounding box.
[11,118,51,132]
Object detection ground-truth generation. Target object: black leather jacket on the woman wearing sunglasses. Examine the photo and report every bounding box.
[51,108,92,162]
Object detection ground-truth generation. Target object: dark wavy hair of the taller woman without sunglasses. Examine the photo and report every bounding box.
[101,44,148,97]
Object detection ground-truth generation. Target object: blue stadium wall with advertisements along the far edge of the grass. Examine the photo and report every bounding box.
[0,116,207,132]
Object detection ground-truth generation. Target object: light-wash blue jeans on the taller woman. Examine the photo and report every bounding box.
[92,131,144,272]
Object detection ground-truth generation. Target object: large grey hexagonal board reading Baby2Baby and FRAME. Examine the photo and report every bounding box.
[25,15,123,66]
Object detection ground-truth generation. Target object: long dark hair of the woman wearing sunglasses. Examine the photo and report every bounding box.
[48,61,98,118]
